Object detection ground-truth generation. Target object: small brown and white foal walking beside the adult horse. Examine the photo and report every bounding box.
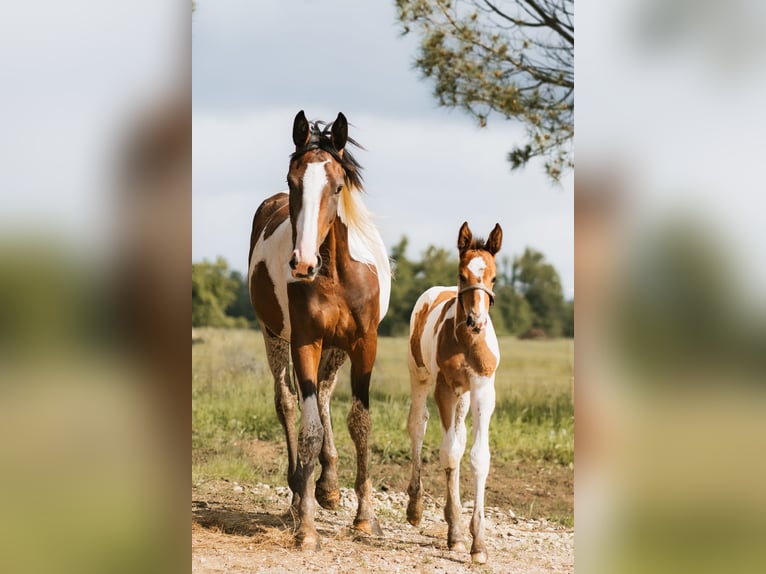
[407,222,503,564]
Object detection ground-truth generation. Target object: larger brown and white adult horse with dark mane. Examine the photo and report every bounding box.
[248,111,391,549]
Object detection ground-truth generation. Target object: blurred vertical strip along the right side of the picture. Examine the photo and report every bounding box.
[575,0,766,572]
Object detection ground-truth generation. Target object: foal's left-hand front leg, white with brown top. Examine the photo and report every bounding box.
[434,374,471,552]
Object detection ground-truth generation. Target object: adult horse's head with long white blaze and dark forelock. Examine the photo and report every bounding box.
[287,110,361,281]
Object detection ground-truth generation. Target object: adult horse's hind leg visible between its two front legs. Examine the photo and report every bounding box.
[315,349,346,510]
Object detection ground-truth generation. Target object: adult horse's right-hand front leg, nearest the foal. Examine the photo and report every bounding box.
[347,331,383,536]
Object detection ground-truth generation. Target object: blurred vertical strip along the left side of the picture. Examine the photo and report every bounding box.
[0,0,191,572]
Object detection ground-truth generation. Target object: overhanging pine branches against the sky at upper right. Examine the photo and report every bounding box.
[396,0,574,181]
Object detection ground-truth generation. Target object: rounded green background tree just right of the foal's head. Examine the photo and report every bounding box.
[511,247,565,337]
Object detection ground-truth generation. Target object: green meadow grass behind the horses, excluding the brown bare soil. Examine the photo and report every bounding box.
[192,329,574,480]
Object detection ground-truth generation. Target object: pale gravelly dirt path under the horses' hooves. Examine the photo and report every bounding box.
[192,481,574,574]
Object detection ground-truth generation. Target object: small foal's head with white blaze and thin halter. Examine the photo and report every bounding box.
[457,222,503,333]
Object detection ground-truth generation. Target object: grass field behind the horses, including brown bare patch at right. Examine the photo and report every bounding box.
[192,329,574,525]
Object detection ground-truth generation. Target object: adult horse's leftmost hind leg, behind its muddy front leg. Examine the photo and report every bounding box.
[261,323,300,510]
